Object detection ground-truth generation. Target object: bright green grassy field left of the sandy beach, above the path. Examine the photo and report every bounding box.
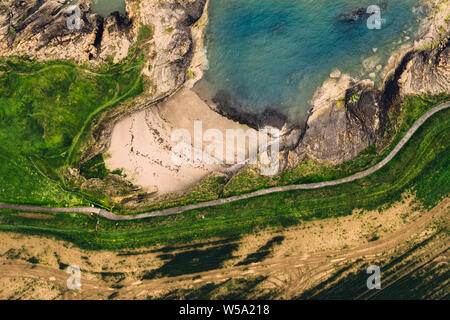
[0,58,142,206]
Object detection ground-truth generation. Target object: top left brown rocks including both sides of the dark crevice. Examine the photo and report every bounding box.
[0,0,132,63]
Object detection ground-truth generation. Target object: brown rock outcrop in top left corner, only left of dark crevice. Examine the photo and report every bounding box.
[0,0,102,61]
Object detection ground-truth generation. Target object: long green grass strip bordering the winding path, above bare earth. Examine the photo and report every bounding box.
[0,96,450,249]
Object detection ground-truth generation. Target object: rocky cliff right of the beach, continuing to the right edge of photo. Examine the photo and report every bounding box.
[287,35,450,166]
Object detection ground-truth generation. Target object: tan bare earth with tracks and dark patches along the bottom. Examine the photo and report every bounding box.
[0,196,450,299]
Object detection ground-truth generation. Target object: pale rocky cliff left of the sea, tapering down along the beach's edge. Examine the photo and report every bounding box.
[78,0,211,160]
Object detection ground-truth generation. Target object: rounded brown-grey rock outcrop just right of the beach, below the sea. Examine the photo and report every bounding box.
[294,82,386,164]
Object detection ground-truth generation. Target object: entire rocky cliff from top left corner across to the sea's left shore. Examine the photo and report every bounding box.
[0,0,206,95]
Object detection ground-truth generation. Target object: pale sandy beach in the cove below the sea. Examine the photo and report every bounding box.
[105,89,266,195]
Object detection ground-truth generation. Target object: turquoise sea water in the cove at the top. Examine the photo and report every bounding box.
[202,0,421,119]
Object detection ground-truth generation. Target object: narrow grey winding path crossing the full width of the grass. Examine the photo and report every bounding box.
[0,102,450,221]
